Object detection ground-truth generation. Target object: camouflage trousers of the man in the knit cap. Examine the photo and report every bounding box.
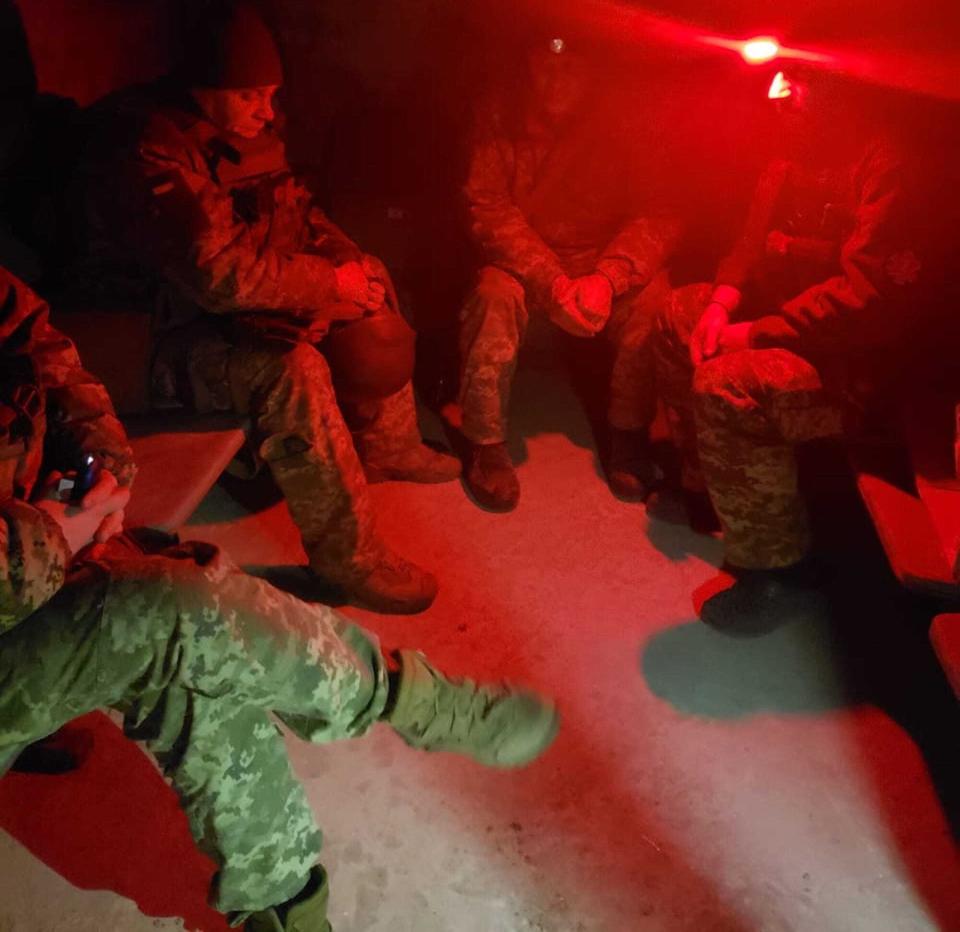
[180,327,420,583]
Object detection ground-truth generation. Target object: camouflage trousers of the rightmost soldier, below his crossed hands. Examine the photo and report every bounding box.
[657,285,843,569]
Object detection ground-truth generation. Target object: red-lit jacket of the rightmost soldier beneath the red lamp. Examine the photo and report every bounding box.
[717,140,937,362]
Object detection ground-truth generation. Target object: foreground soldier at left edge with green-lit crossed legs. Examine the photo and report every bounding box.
[0,270,558,932]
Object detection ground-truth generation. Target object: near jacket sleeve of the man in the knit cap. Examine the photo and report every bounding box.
[122,119,336,316]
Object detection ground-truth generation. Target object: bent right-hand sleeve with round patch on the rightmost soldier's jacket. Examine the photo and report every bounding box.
[750,146,922,353]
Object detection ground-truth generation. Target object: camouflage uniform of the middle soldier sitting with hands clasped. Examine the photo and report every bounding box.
[460,98,679,444]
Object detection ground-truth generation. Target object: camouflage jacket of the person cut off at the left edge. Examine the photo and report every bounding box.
[0,269,134,634]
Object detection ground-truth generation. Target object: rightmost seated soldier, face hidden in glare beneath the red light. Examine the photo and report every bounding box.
[657,66,943,634]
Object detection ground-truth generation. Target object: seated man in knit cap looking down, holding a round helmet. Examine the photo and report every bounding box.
[70,3,460,612]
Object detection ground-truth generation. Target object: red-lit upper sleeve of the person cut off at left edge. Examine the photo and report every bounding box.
[0,272,135,485]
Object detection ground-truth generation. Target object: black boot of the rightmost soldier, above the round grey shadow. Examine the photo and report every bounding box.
[700,559,829,638]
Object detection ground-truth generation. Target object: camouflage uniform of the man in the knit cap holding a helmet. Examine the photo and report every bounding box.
[75,83,432,582]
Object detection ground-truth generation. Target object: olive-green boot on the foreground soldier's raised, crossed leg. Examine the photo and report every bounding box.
[385,651,560,768]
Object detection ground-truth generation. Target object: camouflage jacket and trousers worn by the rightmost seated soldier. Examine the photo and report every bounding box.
[656,141,930,569]
